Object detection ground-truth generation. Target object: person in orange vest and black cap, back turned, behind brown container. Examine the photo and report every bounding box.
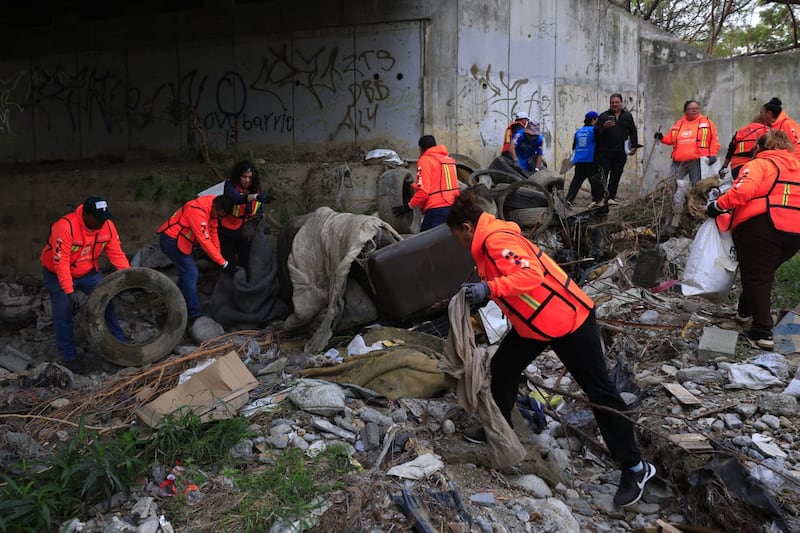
[393,135,460,231]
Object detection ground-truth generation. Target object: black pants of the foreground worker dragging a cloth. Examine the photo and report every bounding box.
[491,311,642,468]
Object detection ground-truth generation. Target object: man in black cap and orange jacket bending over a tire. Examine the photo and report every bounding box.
[41,196,131,373]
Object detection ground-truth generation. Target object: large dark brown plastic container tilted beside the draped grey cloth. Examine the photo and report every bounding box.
[366,224,478,322]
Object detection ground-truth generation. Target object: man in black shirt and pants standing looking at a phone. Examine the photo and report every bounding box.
[594,93,640,205]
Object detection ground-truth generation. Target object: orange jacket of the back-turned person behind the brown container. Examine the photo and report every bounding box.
[408,144,461,213]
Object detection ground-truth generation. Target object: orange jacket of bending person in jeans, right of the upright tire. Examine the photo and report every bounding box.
[156,195,225,265]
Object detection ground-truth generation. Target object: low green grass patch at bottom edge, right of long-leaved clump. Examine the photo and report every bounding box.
[220,445,350,533]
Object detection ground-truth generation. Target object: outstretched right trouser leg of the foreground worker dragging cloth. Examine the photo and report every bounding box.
[550,311,642,468]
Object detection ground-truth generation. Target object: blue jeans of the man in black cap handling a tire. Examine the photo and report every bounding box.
[42,268,127,361]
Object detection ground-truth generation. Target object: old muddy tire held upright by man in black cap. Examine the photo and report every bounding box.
[83,268,188,366]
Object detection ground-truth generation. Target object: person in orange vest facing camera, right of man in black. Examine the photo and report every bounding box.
[655,100,720,232]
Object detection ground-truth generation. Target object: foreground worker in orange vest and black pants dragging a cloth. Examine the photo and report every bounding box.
[447,190,655,506]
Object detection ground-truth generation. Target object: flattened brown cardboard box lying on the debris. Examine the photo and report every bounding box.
[136,352,258,427]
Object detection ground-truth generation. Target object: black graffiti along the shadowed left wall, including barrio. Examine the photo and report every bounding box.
[0,34,420,156]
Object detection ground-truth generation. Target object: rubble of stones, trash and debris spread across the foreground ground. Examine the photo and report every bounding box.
[0,202,800,532]
